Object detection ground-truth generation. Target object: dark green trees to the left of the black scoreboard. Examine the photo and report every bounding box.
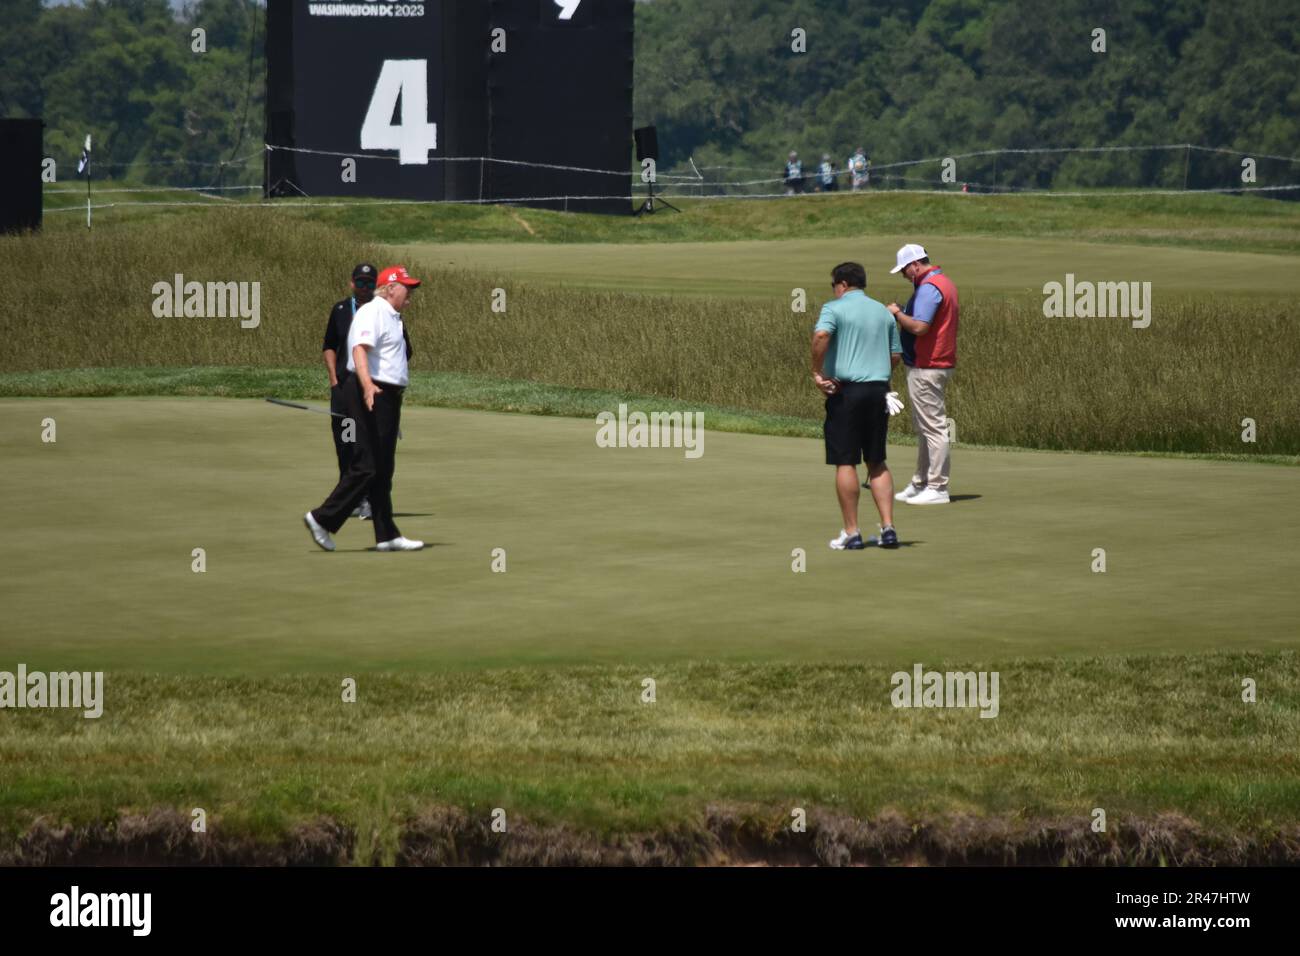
[0,0,267,186]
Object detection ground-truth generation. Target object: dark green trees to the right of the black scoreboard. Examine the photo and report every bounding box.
[636,0,1300,189]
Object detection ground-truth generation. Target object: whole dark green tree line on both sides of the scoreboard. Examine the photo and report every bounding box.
[0,0,1300,189]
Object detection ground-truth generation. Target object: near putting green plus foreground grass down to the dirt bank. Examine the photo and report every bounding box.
[0,398,1300,857]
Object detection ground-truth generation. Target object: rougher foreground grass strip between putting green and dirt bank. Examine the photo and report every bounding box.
[0,649,1300,862]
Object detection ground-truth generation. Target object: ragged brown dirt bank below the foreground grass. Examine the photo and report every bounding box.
[0,808,1300,866]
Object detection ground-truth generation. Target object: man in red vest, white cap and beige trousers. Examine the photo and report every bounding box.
[887,243,961,505]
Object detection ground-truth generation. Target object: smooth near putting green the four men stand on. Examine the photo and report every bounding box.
[0,399,1300,674]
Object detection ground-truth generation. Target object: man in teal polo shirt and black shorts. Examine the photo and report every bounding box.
[813,263,902,551]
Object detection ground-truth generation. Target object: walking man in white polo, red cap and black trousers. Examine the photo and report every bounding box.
[303,265,424,551]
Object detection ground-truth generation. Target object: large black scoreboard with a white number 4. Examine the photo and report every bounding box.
[265,0,633,213]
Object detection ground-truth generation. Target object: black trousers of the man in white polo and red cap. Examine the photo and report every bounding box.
[312,375,404,542]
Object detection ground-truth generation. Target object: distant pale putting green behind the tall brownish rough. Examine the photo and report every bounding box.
[389,235,1300,302]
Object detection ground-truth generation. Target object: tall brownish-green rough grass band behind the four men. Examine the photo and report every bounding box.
[0,211,1300,454]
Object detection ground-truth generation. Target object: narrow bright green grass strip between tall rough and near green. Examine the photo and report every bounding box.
[0,367,1300,467]
